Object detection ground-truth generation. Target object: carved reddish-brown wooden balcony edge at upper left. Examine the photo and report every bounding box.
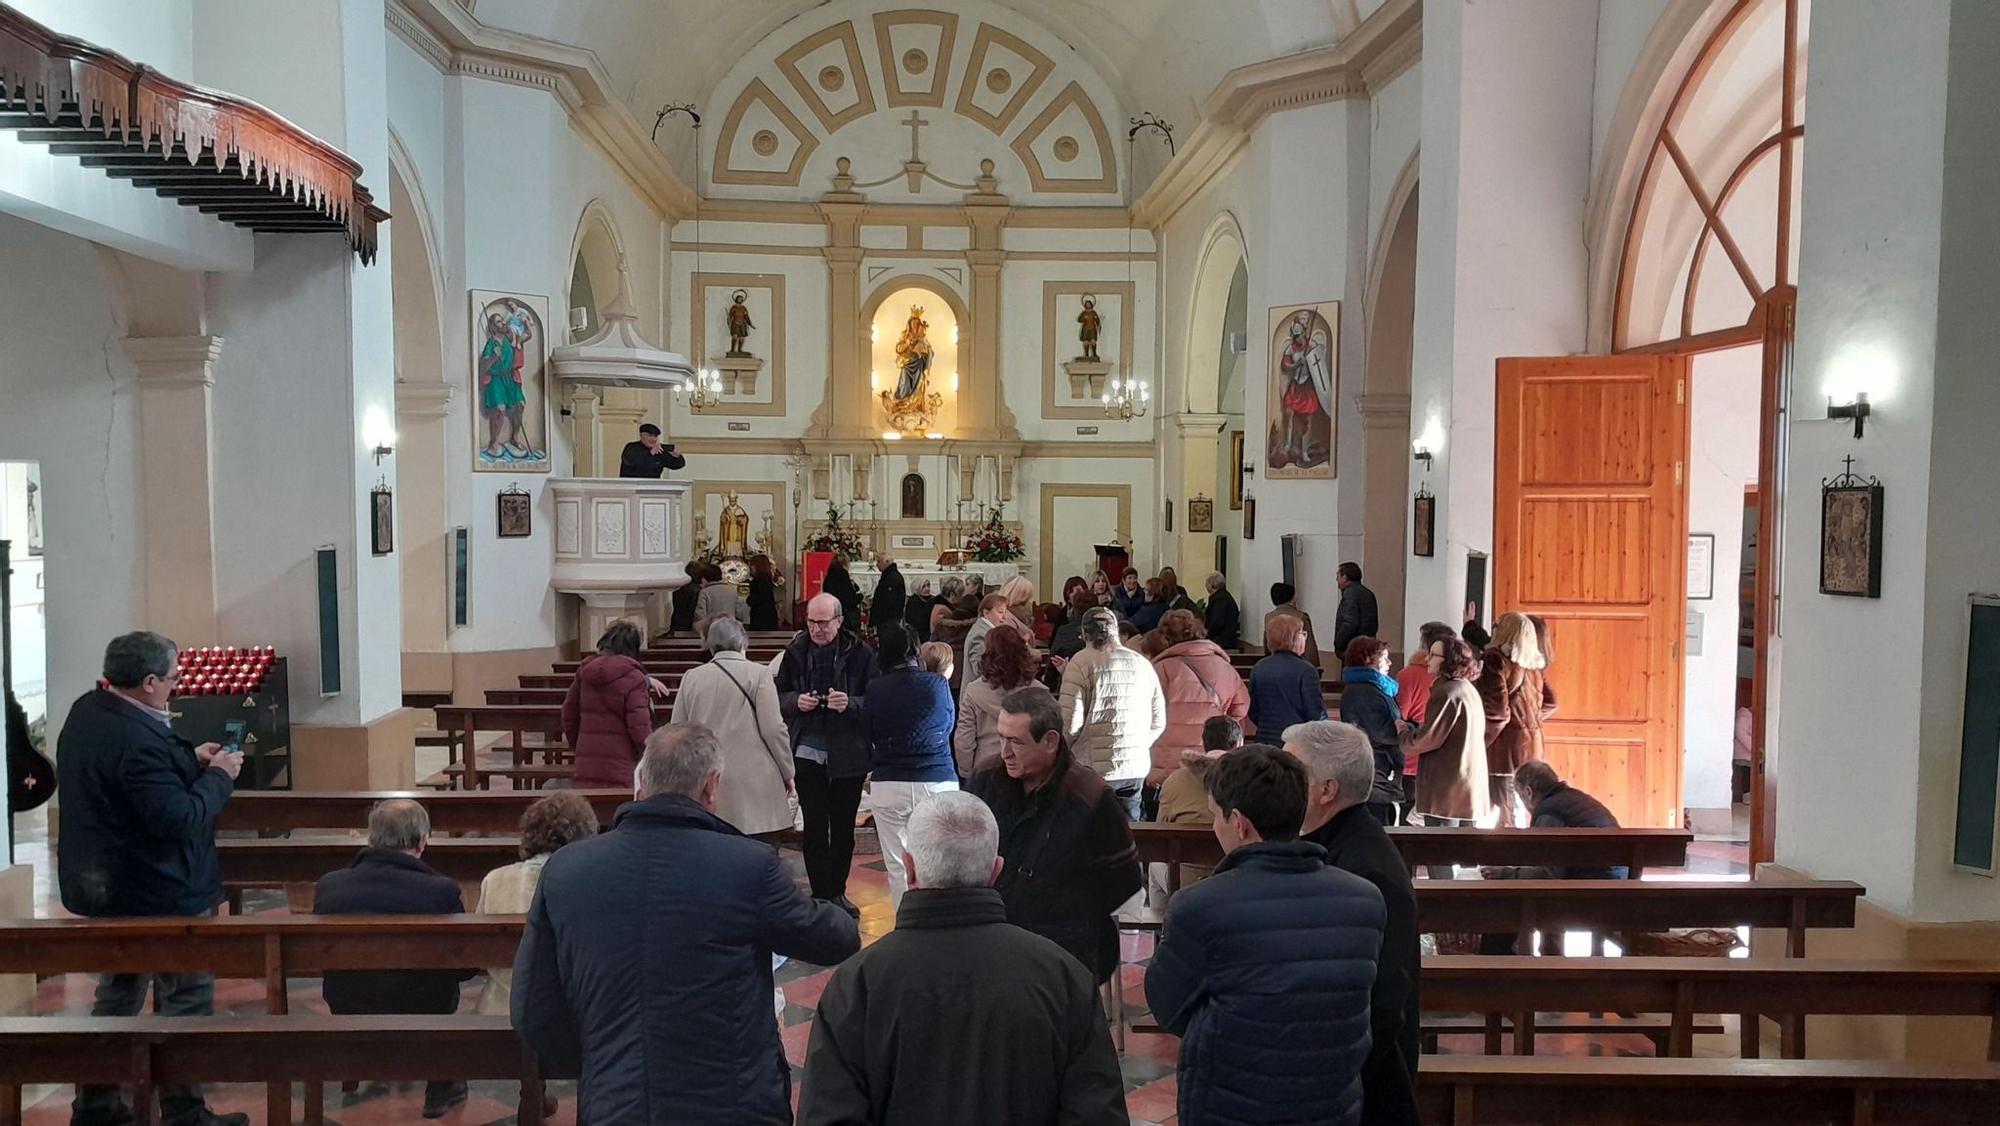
[0,4,388,262]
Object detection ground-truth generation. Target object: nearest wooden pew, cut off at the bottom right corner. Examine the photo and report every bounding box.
[1416,1056,2000,1126]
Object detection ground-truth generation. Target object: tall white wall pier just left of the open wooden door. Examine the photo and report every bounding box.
[1404,0,1598,636]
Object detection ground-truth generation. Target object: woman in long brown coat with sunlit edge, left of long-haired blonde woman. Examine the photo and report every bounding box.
[1404,638,1492,852]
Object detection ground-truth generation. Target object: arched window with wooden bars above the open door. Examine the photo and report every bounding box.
[1612,0,1810,352]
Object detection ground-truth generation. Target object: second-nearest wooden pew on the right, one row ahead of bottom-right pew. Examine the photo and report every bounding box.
[1422,956,2000,1062]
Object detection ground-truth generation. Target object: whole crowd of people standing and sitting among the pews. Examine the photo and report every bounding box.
[47,558,1620,1126]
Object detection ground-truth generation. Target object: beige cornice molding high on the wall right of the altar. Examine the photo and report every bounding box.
[1132,0,1424,230]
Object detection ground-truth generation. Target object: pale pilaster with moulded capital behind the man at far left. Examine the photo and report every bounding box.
[124,336,222,646]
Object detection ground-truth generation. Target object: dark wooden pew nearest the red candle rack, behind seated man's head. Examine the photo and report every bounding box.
[216,790,632,834]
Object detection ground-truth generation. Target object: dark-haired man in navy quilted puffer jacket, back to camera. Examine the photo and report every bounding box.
[1146,746,1384,1126]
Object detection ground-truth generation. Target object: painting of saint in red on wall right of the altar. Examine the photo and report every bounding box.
[1264,302,1340,480]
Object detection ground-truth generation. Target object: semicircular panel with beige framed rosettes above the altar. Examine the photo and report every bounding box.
[708,0,1124,204]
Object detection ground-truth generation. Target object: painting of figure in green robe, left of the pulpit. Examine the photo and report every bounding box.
[472,290,550,472]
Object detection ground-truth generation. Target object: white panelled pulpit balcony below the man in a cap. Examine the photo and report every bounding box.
[548,478,692,650]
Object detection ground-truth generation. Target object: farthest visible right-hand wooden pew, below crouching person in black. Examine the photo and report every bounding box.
[1132,822,1694,892]
